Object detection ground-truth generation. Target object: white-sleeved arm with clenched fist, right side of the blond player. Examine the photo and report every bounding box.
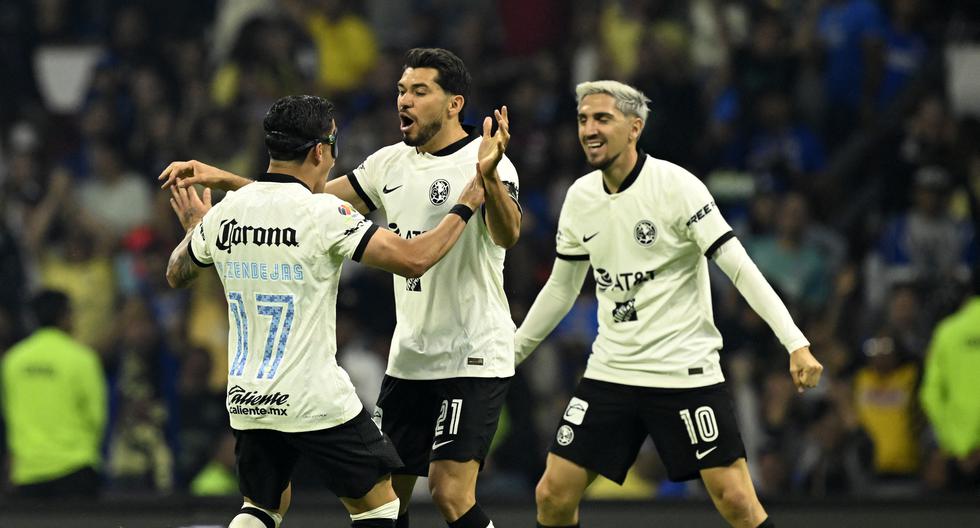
[714,238,823,392]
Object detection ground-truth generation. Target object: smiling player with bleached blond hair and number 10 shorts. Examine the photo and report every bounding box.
[515,81,822,528]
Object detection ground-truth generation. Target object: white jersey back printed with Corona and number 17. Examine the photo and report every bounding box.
[188,174,377,432]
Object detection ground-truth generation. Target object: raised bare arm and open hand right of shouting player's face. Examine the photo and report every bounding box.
[479,106,521,249]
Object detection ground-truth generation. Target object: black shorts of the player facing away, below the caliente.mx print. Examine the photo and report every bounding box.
[234,409,402,510]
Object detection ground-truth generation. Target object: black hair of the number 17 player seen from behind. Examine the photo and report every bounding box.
[262,95,334,161]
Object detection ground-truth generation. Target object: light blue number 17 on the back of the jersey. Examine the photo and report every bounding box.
[228,292,295,379]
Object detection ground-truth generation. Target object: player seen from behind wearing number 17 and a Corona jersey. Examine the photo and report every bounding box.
[167,96,506,528]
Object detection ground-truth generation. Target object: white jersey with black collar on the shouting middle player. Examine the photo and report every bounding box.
[347,136,519,380]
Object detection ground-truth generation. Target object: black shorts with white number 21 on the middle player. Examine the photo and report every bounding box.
[374,376,510,477]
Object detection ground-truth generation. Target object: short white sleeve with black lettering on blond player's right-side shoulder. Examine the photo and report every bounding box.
[675,169,734,258]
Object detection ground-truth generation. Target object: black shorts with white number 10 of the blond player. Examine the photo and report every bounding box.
[550,378,745,484]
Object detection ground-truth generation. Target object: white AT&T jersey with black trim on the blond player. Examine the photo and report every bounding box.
[557,152,732,388]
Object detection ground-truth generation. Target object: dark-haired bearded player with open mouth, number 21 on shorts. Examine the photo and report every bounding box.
[160,49,521,528]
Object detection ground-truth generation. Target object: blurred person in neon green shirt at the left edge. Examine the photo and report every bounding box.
[0,290,108,498]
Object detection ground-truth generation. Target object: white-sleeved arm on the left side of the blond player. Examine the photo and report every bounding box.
[514,258,589,365]
